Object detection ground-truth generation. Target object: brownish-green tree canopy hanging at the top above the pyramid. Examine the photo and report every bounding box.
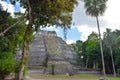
[11,0,77,30]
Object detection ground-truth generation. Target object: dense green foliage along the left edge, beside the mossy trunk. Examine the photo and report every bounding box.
[0,9,25,80]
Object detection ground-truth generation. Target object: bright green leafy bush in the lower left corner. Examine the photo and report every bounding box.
[0,52,15,80]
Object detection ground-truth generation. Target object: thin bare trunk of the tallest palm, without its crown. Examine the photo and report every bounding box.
[96,16,106,80]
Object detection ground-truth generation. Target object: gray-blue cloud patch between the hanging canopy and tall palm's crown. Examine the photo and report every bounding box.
[72,1,107,27]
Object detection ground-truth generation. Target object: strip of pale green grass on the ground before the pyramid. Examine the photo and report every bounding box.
[28,74,120,80]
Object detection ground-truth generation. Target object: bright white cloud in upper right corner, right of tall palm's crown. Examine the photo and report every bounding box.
[103,0,120,27]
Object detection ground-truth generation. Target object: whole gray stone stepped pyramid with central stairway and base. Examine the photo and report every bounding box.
[16,30,75,74]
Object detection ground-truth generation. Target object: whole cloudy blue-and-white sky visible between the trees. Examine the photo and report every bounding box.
[0,0,120,44]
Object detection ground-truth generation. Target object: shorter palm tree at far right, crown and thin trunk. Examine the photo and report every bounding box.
[104,28,116,77]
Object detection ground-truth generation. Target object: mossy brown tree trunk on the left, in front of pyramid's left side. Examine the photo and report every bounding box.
[17,0,32,80]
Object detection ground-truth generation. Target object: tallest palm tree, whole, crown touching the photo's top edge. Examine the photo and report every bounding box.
[84,0,107,80]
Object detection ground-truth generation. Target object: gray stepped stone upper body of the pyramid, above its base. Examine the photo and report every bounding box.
[28,30,75,66]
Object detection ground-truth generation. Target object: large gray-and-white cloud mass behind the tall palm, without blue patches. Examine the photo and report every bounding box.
[73,0,120,41]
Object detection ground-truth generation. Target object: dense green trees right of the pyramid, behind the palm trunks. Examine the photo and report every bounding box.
[72,29,120,74]
